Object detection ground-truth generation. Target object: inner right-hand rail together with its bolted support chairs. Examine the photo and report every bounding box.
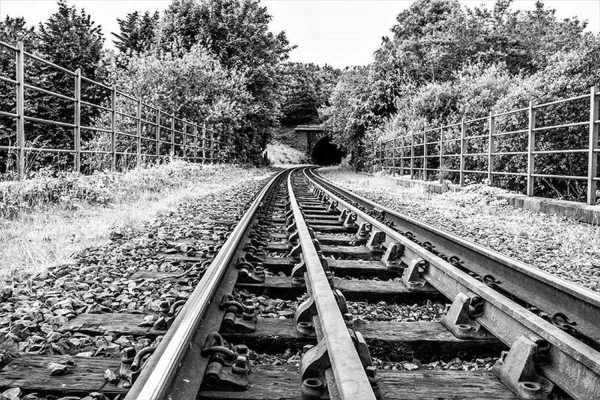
[304,170,600,400]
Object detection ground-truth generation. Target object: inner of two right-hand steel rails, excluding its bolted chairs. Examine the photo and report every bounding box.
[304,169,600,400]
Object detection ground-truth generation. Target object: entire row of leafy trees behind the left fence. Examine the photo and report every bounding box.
[0,0,339,172]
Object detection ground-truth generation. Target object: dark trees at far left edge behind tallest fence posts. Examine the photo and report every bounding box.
[0,0,106,171]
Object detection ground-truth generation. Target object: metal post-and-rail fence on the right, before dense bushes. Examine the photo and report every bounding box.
[375,87,600,205]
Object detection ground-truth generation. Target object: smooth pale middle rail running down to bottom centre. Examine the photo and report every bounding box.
[287,173,375,400]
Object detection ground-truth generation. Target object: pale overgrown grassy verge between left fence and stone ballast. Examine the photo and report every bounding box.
[0,161,272,281]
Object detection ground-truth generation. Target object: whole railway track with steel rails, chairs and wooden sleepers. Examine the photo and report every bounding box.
[0,168,600,400]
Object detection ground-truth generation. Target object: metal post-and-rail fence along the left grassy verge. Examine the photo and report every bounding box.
[0,42,233,177]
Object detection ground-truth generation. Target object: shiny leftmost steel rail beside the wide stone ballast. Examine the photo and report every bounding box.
[125,170,288,400]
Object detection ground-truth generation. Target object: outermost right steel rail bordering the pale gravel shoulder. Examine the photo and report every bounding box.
[310,171,600,343]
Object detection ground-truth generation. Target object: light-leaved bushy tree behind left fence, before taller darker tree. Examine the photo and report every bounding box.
[113,45,253,161]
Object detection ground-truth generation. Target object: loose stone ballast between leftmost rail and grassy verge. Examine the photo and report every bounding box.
[0,179,267,400]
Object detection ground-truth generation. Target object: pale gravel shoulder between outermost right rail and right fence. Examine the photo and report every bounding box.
[319,167,600,292]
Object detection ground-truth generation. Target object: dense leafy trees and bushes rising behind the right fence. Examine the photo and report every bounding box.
[320,0,600,200]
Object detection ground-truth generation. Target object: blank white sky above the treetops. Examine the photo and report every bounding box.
[0,0,600,67]
